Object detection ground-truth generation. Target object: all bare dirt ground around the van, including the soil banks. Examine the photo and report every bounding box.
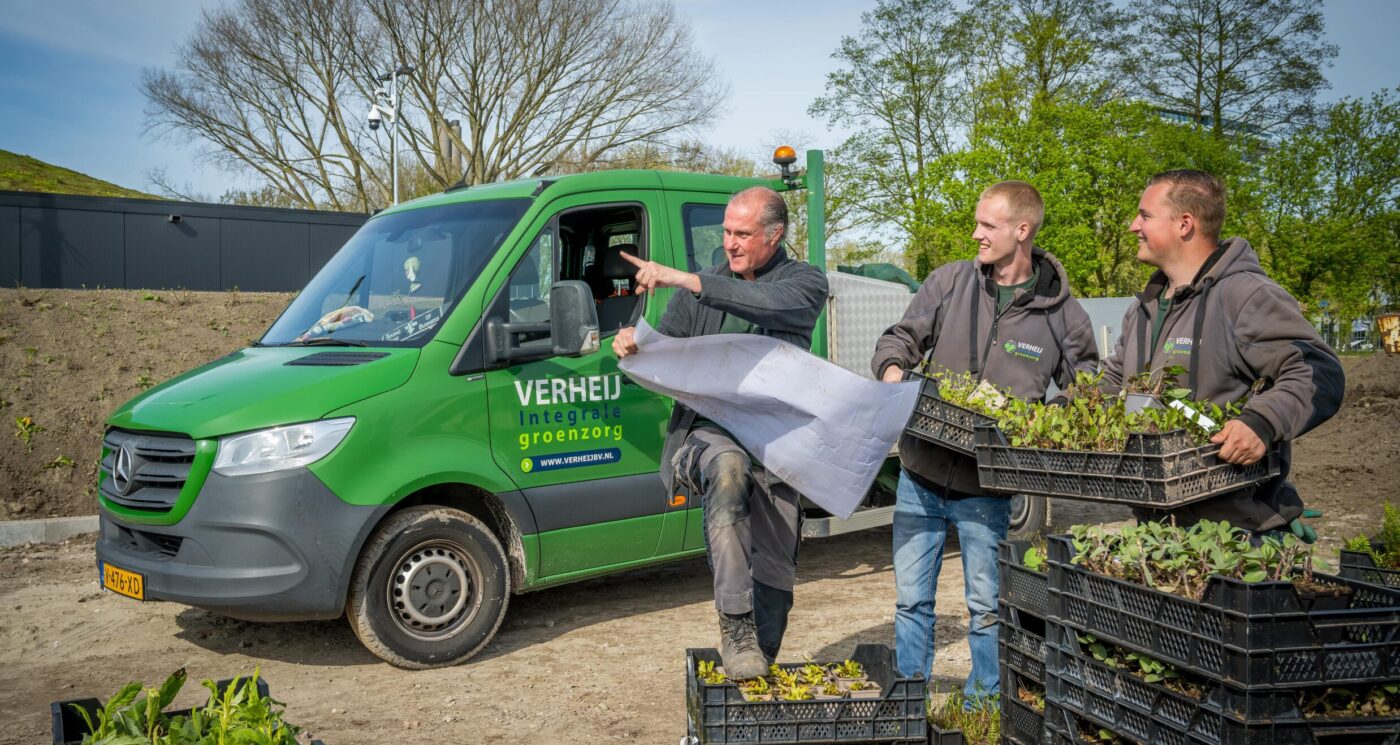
[0,290,1400,745]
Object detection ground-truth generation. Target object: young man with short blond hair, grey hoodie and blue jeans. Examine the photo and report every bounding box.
[871,181,1099,706]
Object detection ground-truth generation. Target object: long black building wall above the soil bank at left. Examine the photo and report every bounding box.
[0,190,370,291]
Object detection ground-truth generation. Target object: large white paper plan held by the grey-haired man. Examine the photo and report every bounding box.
[619,321,918,520]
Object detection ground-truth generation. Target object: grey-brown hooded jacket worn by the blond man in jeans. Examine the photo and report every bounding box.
[871,246,1099,497]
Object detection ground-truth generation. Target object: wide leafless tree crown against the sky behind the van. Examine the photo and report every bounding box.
[141,0,724,210]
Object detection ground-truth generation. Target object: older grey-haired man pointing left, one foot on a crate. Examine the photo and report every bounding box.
[613,186,827,679]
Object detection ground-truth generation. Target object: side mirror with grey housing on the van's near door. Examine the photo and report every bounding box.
[486,280,599,364]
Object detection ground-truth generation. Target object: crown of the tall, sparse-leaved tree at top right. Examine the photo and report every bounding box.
[1124,0,1337,136]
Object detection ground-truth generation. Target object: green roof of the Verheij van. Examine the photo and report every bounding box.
[381,171,788,214]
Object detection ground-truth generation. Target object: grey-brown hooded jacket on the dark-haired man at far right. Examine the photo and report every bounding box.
[1103,238,1345,531]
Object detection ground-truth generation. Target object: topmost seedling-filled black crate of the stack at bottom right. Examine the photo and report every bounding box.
[1049,521,1400,688]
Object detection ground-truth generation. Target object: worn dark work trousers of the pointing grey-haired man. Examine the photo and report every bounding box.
[675,424,801,660]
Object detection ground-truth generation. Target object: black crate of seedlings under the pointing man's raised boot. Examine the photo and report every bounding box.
[686,644,928,745]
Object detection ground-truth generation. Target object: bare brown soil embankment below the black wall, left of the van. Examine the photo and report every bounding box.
[0,288,293,520]
